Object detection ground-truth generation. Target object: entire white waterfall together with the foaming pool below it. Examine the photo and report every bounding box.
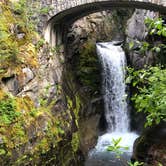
[85,42,138,166]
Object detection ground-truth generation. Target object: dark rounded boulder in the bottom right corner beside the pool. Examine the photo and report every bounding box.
[132,122,166,166]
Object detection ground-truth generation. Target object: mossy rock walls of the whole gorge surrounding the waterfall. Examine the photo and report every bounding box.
[0,1,166,166]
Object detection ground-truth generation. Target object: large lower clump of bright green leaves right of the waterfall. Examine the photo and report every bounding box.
[126,67,166,126]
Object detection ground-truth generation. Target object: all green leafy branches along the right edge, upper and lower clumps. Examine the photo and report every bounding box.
[126,18,166,126]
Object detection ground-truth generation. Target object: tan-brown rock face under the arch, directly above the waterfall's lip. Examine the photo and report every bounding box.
[66,9,132,56]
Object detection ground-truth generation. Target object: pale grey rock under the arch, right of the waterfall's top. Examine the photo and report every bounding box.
[126,9,158,69]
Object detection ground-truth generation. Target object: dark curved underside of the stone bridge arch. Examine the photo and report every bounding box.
[44,1,166,46]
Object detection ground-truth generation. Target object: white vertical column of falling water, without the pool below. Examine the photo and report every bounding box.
[97,43,129,132]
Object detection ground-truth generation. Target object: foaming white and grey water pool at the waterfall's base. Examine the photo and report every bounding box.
[85,132,138,166]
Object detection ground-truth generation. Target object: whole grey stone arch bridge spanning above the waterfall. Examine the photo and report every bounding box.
[41,0,166,46]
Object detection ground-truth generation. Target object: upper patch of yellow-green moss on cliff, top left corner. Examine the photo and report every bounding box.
[0,0,37,78]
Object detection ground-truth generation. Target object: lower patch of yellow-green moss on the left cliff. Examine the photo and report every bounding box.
[0,87,72,164]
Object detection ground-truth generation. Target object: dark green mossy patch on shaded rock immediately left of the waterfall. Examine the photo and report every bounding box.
[76,41,101,93]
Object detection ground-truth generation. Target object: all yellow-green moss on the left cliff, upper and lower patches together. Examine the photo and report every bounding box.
[0,0,82,165]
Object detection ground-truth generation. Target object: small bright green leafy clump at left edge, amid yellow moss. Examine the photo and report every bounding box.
[0,96,20,125]
